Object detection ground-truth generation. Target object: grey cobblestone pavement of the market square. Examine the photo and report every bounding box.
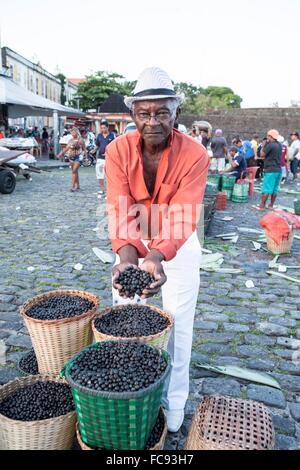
[0,168,300,449]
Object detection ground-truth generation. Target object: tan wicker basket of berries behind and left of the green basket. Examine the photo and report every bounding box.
[20,290,99,374]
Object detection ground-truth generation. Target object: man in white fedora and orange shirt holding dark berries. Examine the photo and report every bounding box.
[105,67,209,432]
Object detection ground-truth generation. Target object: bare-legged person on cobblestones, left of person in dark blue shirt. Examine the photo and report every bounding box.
[57,127,87,193]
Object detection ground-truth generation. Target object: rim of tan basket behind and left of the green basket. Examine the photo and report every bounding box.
[19,289,101,325]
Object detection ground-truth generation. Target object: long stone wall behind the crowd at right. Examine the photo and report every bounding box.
[180,108,300,139]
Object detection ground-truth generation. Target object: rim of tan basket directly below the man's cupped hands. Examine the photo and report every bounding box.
[92,304,174,341]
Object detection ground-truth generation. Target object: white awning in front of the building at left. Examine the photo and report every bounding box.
[0,76,85,118]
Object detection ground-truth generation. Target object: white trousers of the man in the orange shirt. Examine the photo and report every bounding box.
[112,232,201,410]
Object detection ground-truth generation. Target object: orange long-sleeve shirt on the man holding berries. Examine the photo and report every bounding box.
[105,130,209,261]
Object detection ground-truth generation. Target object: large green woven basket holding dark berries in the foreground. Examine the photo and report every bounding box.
[61,341,171,450]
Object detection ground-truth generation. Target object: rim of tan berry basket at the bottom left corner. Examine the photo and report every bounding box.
[0,374,76,427]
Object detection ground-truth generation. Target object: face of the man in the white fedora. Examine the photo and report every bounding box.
[131,99,179,145]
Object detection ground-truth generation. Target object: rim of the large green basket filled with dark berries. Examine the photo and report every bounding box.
[61,341,171,400]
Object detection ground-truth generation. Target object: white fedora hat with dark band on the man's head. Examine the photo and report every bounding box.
[124,67,184,109]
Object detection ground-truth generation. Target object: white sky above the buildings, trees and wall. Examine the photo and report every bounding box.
[0,0,300,107]
